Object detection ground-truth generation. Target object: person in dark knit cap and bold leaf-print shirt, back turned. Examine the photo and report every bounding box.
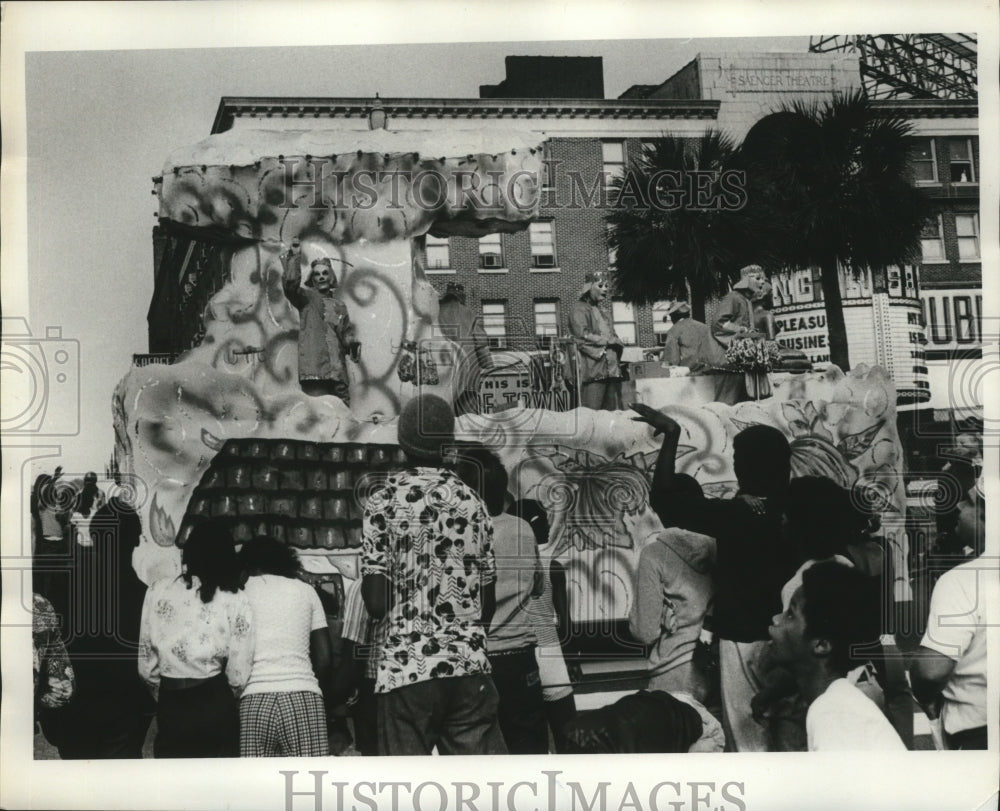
[361,394,507,755]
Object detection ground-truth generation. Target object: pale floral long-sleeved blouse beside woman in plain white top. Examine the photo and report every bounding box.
[139,577,254,695]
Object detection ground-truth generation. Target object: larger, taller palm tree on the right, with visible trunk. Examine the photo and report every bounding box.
[737,91,931,370]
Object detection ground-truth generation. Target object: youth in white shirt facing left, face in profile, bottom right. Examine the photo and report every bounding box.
[769,561,906,752]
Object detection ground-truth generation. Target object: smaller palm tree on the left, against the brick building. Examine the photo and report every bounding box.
[605,131,739,321]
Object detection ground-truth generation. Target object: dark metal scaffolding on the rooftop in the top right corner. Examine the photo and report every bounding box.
[809,34,978,99]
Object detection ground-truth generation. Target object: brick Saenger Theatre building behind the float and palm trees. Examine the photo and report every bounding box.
[149,53,982,412]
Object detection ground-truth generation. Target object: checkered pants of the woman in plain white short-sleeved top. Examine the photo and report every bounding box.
[240,690,330,757]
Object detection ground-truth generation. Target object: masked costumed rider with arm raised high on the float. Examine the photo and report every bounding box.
[281,242,361,406]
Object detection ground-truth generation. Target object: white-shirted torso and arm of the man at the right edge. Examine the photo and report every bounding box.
[910,558,1000,749]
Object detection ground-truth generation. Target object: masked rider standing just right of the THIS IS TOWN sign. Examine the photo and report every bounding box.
[569,273,624,411]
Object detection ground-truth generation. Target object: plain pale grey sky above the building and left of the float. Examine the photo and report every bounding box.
[15,31,808,473]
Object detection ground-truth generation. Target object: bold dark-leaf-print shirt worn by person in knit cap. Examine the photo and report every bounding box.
[361,467,496,693]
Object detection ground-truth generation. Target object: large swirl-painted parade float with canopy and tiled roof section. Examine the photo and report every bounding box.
[113,130,909,636]
